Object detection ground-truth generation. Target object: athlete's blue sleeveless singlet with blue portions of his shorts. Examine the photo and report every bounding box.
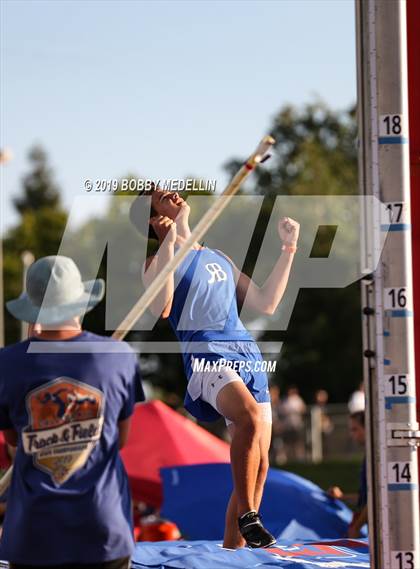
[169,248,270,421]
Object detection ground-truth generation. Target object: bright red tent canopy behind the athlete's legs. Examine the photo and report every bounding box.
[121,401,230,507]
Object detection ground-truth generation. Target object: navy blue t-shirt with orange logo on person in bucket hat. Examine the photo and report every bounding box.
[0,332,144,566]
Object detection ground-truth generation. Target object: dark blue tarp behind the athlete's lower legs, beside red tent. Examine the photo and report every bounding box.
[161,464,364,540]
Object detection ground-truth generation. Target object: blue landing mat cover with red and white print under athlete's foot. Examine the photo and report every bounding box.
[133,540,370,569]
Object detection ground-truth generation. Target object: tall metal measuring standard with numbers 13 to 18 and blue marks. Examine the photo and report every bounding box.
[356,0,420,569]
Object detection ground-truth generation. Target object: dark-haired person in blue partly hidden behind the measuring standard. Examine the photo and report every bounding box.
[327,411,367,538]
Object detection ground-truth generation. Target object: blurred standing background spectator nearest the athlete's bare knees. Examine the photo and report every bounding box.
[282,385,306,461]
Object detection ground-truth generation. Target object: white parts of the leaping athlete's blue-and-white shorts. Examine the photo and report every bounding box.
[188,367,273,426]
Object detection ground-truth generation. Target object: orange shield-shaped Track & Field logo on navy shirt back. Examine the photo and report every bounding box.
[22,377,104,486]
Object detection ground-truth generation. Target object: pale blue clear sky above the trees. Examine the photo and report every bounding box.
[0,0,356,231]
